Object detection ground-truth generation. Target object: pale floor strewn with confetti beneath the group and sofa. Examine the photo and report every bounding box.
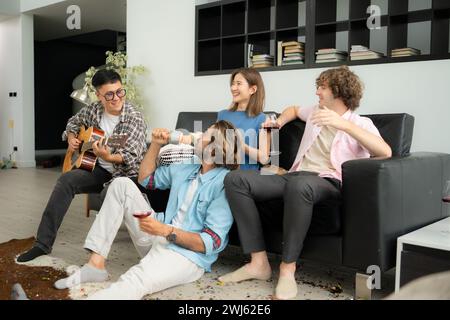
[0,169,394,300]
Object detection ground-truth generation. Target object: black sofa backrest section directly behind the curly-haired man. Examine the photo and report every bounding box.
[280,113,414,169]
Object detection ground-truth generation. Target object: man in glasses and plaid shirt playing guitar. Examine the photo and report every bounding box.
[17,70,147,262]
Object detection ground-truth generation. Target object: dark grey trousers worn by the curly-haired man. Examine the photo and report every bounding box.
[224,170,341,263]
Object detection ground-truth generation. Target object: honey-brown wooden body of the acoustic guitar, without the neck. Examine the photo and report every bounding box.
[63,127,105,173]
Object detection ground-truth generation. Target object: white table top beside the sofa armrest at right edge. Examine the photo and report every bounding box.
[397,217,450,251]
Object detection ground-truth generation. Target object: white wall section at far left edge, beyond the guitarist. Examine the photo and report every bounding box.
[0,15,35,167]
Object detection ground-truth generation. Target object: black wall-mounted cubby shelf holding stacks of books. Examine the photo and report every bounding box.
[195,0,450,75]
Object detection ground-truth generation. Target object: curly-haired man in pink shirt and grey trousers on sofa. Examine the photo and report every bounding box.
[219,66,392,299]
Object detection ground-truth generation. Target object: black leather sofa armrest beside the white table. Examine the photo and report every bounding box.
[342,152,450,271]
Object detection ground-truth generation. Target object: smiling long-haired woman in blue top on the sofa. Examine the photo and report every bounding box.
[180,68,270,170]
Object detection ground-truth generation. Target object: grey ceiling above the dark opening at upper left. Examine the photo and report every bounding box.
[30,0,127,41]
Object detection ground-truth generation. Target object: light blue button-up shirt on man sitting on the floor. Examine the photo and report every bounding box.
[141,162,233,272]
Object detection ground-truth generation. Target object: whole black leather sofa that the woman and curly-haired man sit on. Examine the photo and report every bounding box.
[91,112,450,272]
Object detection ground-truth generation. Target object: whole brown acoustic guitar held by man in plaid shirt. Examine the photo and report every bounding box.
[63,126,128,173]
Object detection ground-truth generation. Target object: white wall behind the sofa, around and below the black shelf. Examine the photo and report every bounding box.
[127,0,450,153]
